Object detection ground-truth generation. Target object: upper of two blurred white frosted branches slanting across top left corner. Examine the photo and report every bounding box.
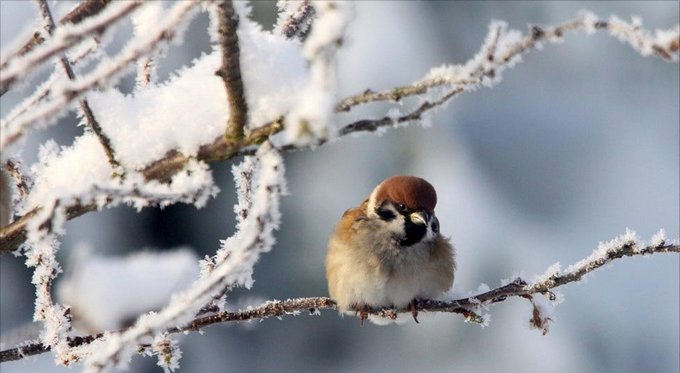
[0,1,141,93]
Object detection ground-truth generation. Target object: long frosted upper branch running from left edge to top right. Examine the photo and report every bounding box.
[0,15,680,254]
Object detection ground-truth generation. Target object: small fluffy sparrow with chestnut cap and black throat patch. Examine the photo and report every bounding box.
[326,176,456,325]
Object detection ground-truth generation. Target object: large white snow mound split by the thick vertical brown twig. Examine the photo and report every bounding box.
[71,1,307,168]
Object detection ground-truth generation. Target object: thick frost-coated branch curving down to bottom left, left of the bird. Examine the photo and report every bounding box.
[80,143,285,371]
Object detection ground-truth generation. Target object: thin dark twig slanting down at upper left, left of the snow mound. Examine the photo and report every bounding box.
[36,0,120,172]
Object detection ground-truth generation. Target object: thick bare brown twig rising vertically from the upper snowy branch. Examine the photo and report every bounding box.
[215,0,248,141]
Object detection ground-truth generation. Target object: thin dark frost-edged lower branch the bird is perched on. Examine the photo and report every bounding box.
[0,237,680,362]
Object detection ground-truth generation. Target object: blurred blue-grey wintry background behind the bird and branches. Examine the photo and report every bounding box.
[0,0,680,373]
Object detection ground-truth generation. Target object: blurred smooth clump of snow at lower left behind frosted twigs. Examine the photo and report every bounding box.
[57,247,198,332]
